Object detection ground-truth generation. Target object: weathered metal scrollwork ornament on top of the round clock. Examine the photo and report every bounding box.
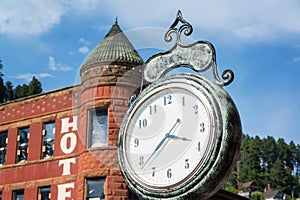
[144,10,234,86]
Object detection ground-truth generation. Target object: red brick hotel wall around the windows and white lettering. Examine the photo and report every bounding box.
[0,67,140,200]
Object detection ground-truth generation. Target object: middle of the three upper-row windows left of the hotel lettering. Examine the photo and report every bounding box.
[16,127,29,163]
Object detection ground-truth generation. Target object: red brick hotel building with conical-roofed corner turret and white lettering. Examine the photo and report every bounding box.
[0,19,246,200]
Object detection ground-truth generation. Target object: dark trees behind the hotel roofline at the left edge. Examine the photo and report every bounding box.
[0,60,43,103]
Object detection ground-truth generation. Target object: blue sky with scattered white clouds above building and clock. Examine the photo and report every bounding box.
[0,0,300,143]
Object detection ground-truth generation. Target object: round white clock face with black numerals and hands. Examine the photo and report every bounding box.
[122,82,216,191]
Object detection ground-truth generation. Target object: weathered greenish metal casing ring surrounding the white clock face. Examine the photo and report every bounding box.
[118,74,241,199]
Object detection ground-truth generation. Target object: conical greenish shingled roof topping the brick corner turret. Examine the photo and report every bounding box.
[83,20,144,67]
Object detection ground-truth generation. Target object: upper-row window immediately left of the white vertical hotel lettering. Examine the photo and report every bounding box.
[42,122,55,158]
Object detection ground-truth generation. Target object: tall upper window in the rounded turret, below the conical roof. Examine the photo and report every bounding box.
[88,109,107,147]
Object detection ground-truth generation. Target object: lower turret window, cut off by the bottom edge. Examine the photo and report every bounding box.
[86,178,105,200]
